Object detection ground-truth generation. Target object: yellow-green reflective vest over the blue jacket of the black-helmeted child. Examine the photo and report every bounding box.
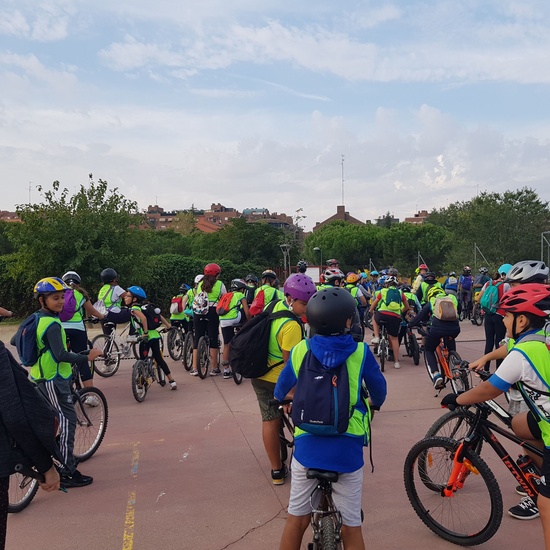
[290,340,370,444]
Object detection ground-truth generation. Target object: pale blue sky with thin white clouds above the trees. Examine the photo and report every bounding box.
[0,0,550,230]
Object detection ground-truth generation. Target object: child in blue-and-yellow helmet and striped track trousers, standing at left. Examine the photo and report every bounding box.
[30,277,101,488]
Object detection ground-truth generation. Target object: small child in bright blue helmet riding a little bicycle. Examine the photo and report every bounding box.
[124,286,178,390]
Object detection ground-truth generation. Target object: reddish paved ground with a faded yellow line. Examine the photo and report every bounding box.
[0,324,542,550]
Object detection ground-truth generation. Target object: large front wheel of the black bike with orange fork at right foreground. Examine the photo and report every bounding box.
[403,437,502,546]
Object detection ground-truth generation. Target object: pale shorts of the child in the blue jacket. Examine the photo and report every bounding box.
[288,457,363,527]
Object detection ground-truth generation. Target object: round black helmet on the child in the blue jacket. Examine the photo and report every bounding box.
[306,287,356,336]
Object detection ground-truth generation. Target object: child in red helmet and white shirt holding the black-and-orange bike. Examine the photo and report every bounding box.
[441,283,550,532]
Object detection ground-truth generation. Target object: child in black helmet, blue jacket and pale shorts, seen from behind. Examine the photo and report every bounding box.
[275,288,386,550]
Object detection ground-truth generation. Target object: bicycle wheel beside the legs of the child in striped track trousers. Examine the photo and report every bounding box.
[73,388,109,462]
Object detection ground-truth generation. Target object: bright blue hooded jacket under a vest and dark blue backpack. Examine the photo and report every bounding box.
[275,334,386,472]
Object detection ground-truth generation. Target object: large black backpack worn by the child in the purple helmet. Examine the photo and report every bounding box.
[229,300,302,378]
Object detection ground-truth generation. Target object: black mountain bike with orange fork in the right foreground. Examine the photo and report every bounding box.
[403,394,543,546]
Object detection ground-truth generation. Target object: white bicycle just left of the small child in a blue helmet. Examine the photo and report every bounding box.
[92,323,139,378]
